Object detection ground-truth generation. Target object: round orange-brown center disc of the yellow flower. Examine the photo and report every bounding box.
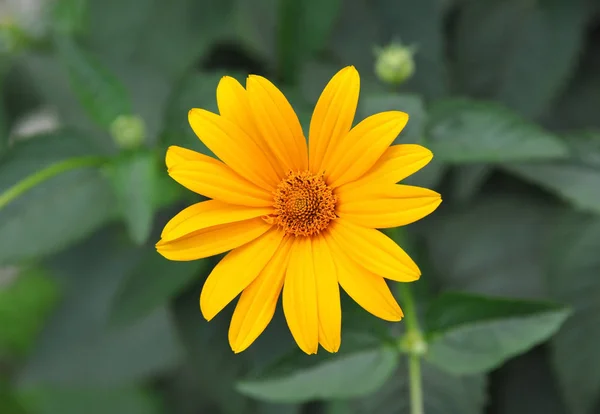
[274,171,337,236]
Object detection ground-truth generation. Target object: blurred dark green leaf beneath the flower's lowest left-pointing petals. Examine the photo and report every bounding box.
[111,249,210,324]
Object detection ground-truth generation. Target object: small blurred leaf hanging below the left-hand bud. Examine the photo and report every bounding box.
[109,151,158,245]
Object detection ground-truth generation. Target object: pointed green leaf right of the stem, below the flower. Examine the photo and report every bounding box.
[426,293,569,375]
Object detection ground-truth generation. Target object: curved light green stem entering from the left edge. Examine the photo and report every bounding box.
[0,156,106,209]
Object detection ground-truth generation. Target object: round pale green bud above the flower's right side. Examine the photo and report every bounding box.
[375,43,415,85]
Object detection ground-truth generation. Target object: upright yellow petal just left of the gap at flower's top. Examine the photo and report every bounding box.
[246,75,308,173]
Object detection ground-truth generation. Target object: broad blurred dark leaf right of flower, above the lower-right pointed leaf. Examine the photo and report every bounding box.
[415,194,555,299]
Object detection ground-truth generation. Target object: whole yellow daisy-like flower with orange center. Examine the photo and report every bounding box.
[156,67,441,354]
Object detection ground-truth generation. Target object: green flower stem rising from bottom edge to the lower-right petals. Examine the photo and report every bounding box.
[398,283,426,414]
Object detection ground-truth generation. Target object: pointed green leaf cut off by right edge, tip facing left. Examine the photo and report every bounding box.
[503,133,600,217]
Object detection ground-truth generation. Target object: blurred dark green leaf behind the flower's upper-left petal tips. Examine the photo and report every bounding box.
[162,73,222,155]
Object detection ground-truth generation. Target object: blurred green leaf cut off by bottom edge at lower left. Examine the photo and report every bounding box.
[18,387,162,414]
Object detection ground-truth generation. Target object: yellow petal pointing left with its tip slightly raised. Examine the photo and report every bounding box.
[167,147,273,207]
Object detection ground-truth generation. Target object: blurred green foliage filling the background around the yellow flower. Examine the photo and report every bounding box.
[0,0,600,414]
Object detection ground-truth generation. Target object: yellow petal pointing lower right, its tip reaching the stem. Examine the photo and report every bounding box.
[326,237,404,321]
